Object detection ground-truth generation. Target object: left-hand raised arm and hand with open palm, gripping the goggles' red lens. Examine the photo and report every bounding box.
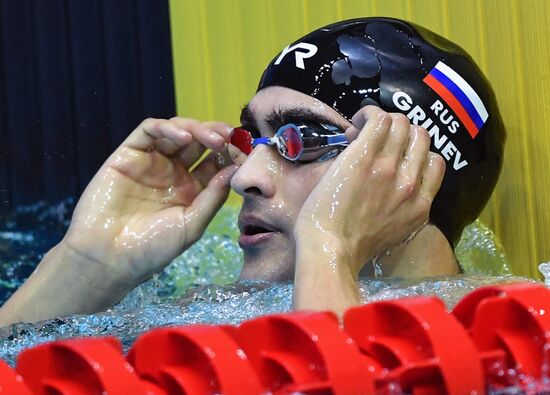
[0,118,236,324]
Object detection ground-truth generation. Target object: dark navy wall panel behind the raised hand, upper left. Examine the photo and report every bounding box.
[0,0,175,218]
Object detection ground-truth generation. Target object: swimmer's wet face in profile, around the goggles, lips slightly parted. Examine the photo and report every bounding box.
[231,87,350,280]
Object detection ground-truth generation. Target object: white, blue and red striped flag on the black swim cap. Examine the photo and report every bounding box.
[423,61,489,139]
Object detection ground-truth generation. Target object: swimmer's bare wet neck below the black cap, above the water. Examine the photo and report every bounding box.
[361,224,460,278]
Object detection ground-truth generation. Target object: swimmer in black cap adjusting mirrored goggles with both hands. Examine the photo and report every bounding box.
[0,18,505,325]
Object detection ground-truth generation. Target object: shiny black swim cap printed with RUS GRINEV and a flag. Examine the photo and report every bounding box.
[258,18,506,245]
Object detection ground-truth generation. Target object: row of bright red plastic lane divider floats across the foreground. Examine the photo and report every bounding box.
[0,283,550,395]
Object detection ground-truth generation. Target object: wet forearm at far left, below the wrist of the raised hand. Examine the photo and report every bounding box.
[0,242,126,326]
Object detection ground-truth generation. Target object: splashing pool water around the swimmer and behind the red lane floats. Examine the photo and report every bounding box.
[0,199,532,372]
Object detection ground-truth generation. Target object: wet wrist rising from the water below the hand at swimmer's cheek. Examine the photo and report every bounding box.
[294,237,361,317]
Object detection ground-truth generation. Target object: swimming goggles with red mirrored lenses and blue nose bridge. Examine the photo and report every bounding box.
[229,122,349,162]
